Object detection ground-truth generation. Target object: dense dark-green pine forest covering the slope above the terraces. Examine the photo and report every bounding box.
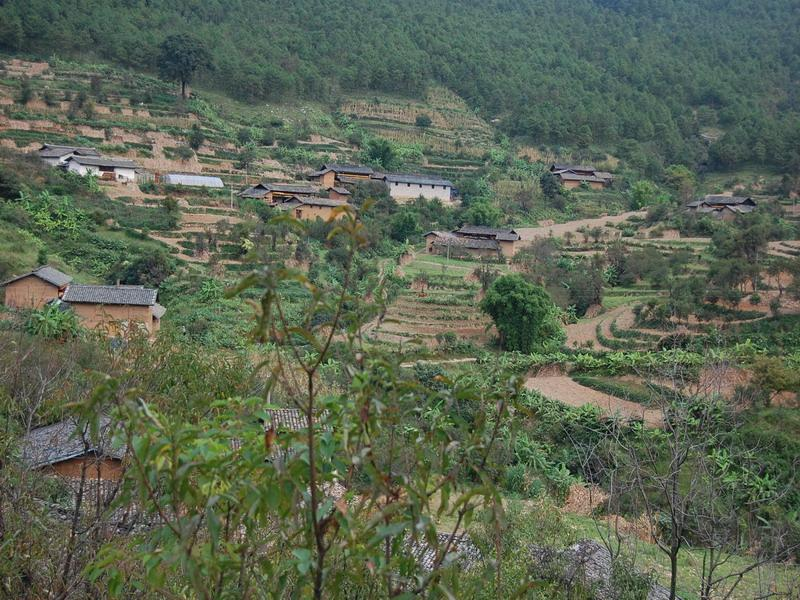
[0,0,800,168]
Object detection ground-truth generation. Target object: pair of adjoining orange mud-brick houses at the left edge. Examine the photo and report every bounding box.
[0,266,167,337]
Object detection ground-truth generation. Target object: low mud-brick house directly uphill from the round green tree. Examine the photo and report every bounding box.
[425,225,520,259]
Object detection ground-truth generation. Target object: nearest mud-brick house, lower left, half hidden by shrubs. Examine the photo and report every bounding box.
[21,417,126,481]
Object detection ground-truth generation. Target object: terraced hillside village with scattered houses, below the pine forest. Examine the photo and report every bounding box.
[0,47,800,600]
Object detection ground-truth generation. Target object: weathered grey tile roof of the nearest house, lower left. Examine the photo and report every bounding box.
[22,416,126,469]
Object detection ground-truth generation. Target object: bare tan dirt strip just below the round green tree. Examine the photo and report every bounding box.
[525,375,661,427]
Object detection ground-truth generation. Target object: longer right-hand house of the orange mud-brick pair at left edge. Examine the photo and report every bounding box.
[61,285,166,337]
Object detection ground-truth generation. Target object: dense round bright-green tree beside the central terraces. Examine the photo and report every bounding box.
[481,275,564,352]
